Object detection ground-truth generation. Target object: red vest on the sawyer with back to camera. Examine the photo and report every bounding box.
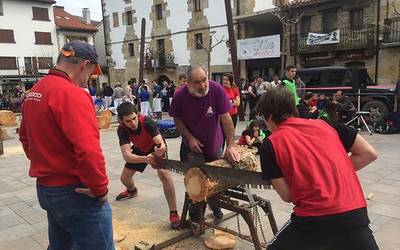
[269,118,367,217]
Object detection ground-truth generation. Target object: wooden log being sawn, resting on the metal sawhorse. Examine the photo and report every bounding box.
[184,147,257,202]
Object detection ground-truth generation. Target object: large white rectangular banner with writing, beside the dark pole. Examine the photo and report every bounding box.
[237,35,281,60]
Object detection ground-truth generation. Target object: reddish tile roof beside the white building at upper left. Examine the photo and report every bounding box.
[54,6,97,32]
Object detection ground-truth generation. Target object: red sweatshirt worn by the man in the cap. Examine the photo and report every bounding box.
[19,69,108,196]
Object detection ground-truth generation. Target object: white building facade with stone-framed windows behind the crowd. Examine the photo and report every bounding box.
[102,0,278,84]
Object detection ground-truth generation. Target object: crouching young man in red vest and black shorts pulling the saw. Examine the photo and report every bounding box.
[116,102,180,229]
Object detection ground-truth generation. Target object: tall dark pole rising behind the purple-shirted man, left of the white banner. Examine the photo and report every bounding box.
[225,0,244,121]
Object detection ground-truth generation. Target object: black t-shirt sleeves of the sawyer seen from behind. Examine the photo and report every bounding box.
[260,122,357,180]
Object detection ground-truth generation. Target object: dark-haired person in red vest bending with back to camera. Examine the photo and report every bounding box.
[257,88,378,250]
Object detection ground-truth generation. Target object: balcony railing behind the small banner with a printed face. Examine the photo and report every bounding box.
[290,24,376,54]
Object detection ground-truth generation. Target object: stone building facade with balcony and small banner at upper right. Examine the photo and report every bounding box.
[275,0,400,85]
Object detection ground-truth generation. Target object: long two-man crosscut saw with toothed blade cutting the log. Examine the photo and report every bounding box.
[160,159,271,189]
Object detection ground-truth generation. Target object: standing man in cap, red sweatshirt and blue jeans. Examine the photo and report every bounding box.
[20,41,114,250]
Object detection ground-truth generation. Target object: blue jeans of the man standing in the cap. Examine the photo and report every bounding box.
[37,185,115,250]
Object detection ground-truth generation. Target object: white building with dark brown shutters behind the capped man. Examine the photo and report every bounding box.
[0,0,58,91]
